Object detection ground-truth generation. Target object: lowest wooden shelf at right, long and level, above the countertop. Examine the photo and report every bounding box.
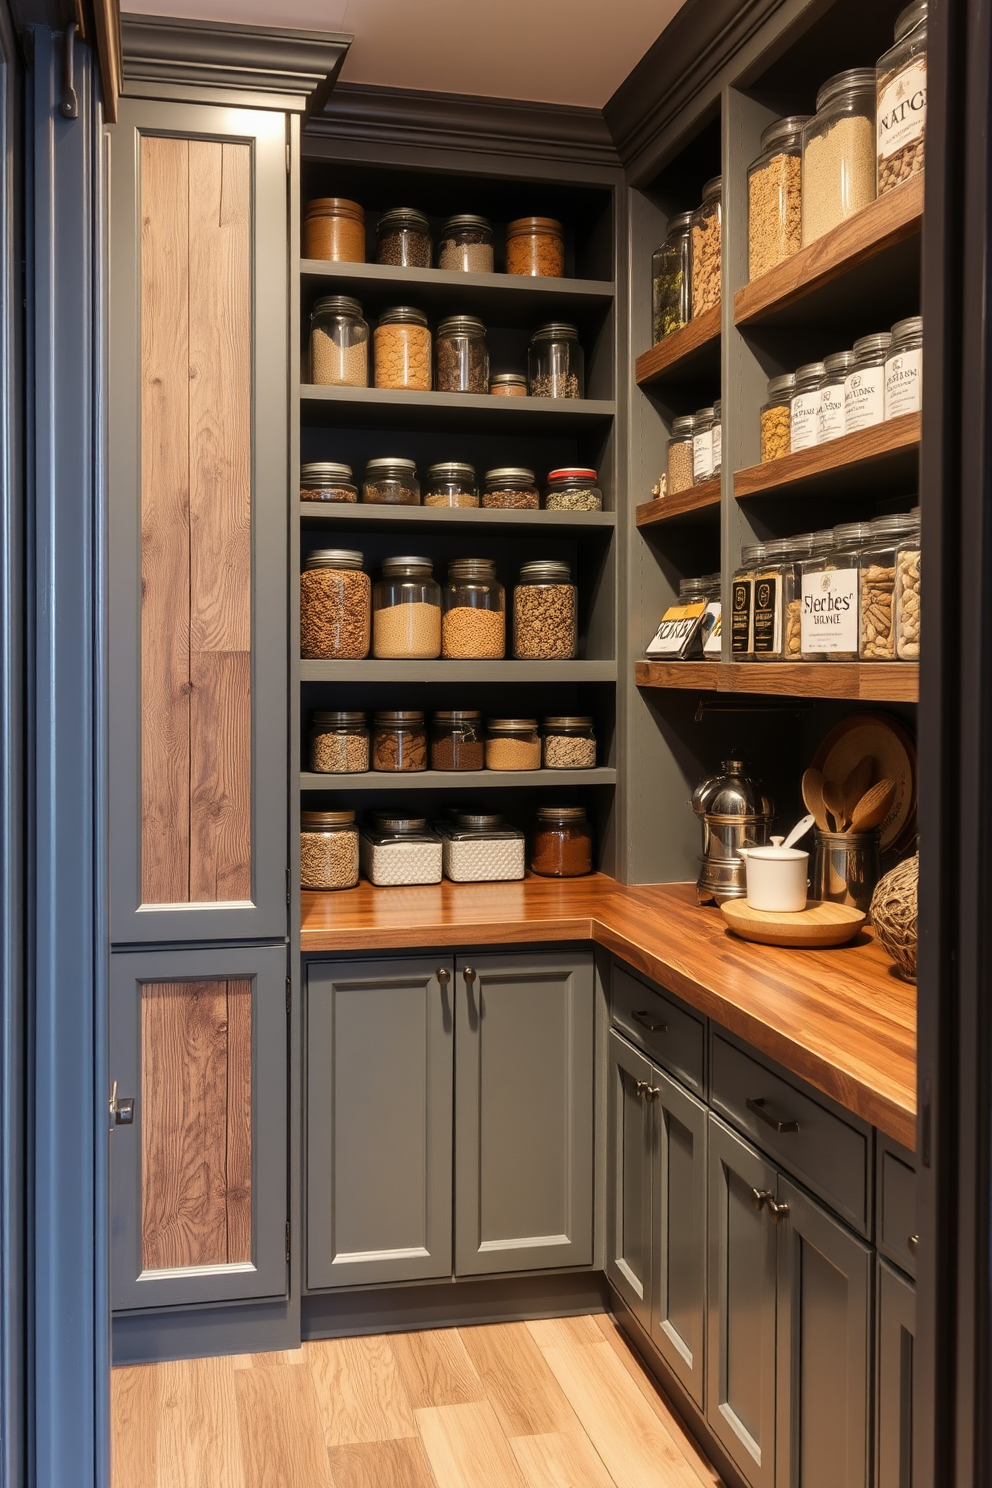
[634,661,919,702]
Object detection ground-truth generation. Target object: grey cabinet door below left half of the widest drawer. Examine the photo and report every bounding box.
[706,1115,779,1488]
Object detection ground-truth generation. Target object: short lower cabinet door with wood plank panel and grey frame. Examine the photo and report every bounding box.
[110,945,289,1309]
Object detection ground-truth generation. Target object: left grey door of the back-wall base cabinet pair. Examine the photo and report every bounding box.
[306,957,452,1290]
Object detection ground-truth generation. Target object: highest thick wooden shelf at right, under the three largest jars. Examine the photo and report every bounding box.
[734,171,924,330]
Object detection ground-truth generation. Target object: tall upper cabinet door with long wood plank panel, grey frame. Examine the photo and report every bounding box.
[109,100,290,943]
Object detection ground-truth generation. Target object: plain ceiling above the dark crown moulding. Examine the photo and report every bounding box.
[123,0,684,109]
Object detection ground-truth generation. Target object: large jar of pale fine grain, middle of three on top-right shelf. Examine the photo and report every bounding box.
[803,67,875,247]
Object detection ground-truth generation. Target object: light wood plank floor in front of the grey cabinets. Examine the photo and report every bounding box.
[113,1317,720,1488]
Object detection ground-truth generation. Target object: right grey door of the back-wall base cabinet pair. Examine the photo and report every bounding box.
[455,951,595,1275]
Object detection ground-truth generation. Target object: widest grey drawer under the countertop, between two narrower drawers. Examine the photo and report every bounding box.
[711,1034,870,1234]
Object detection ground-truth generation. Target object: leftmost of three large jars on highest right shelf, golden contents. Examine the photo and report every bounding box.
[748,113,809,280]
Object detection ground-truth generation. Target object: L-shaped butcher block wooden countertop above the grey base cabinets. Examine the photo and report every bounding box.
[302,873,916,1147]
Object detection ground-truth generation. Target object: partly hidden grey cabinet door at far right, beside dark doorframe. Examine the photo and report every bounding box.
[875,1260,916,1488]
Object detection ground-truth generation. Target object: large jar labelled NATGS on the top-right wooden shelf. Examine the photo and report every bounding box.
[875,0,927,196]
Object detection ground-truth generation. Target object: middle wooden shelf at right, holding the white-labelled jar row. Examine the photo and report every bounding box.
[733,414,922,501]
